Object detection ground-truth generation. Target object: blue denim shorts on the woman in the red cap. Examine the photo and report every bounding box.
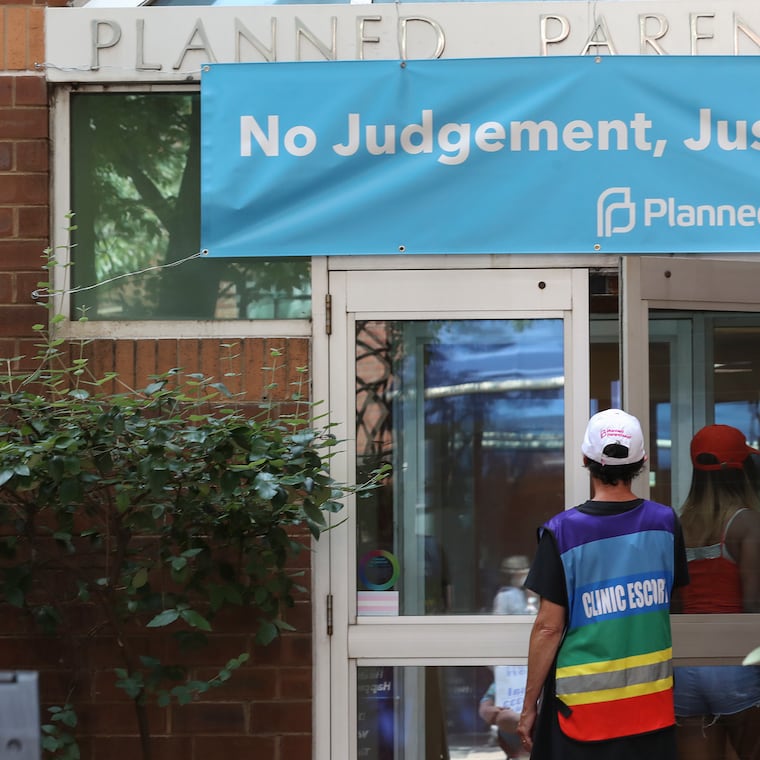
[673,665,760,718]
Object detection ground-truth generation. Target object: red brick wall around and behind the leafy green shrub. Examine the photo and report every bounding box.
[0,0,312,760]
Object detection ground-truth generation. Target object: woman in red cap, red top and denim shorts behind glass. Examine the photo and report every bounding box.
[675,425,760,760]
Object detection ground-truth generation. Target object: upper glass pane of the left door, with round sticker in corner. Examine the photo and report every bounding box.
[356,319,564,615]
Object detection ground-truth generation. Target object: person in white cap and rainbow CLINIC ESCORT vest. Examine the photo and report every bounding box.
[518,409,689,760]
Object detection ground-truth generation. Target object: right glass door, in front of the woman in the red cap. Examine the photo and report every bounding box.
[625,257,760,757]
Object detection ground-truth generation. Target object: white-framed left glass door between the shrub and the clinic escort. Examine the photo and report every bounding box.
[320,269,589,760]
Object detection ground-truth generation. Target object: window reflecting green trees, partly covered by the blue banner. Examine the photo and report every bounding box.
[69,92,311,320]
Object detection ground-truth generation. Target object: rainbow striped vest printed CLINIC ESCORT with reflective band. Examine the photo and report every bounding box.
[542,500,675,741]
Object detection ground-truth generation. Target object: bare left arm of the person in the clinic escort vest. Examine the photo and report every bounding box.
[517,597,565,752]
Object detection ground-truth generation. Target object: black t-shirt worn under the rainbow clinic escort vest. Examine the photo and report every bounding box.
[525,499,689,760]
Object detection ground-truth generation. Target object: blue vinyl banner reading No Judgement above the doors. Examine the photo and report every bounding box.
[201,56,760,257]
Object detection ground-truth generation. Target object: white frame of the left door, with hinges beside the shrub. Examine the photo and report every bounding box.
[312,257,599,760]
